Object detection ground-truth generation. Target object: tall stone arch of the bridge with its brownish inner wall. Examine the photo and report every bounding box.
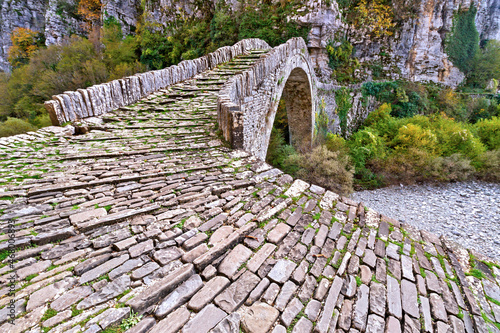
[254,53,316,159]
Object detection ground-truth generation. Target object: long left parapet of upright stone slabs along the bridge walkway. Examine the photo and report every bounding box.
[45,39,270,125]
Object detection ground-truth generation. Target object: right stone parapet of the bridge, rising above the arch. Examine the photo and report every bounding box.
[217,37,307,148]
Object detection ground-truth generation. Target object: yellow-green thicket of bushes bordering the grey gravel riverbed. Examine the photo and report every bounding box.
[347,104,494,187]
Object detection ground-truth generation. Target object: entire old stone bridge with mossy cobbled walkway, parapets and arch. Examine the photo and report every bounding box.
[0,40,500,333]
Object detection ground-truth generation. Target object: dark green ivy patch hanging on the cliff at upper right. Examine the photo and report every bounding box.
[446,5,479,74]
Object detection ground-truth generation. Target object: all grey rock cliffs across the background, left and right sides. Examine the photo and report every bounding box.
[0,0,500,86]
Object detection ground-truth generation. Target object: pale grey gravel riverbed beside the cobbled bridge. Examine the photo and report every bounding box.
[351,181,500,261]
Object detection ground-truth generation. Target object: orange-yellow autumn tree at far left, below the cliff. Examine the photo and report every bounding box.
[8,28,40,68]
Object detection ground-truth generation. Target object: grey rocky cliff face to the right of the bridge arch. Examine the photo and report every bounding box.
[308,0,500,86]
